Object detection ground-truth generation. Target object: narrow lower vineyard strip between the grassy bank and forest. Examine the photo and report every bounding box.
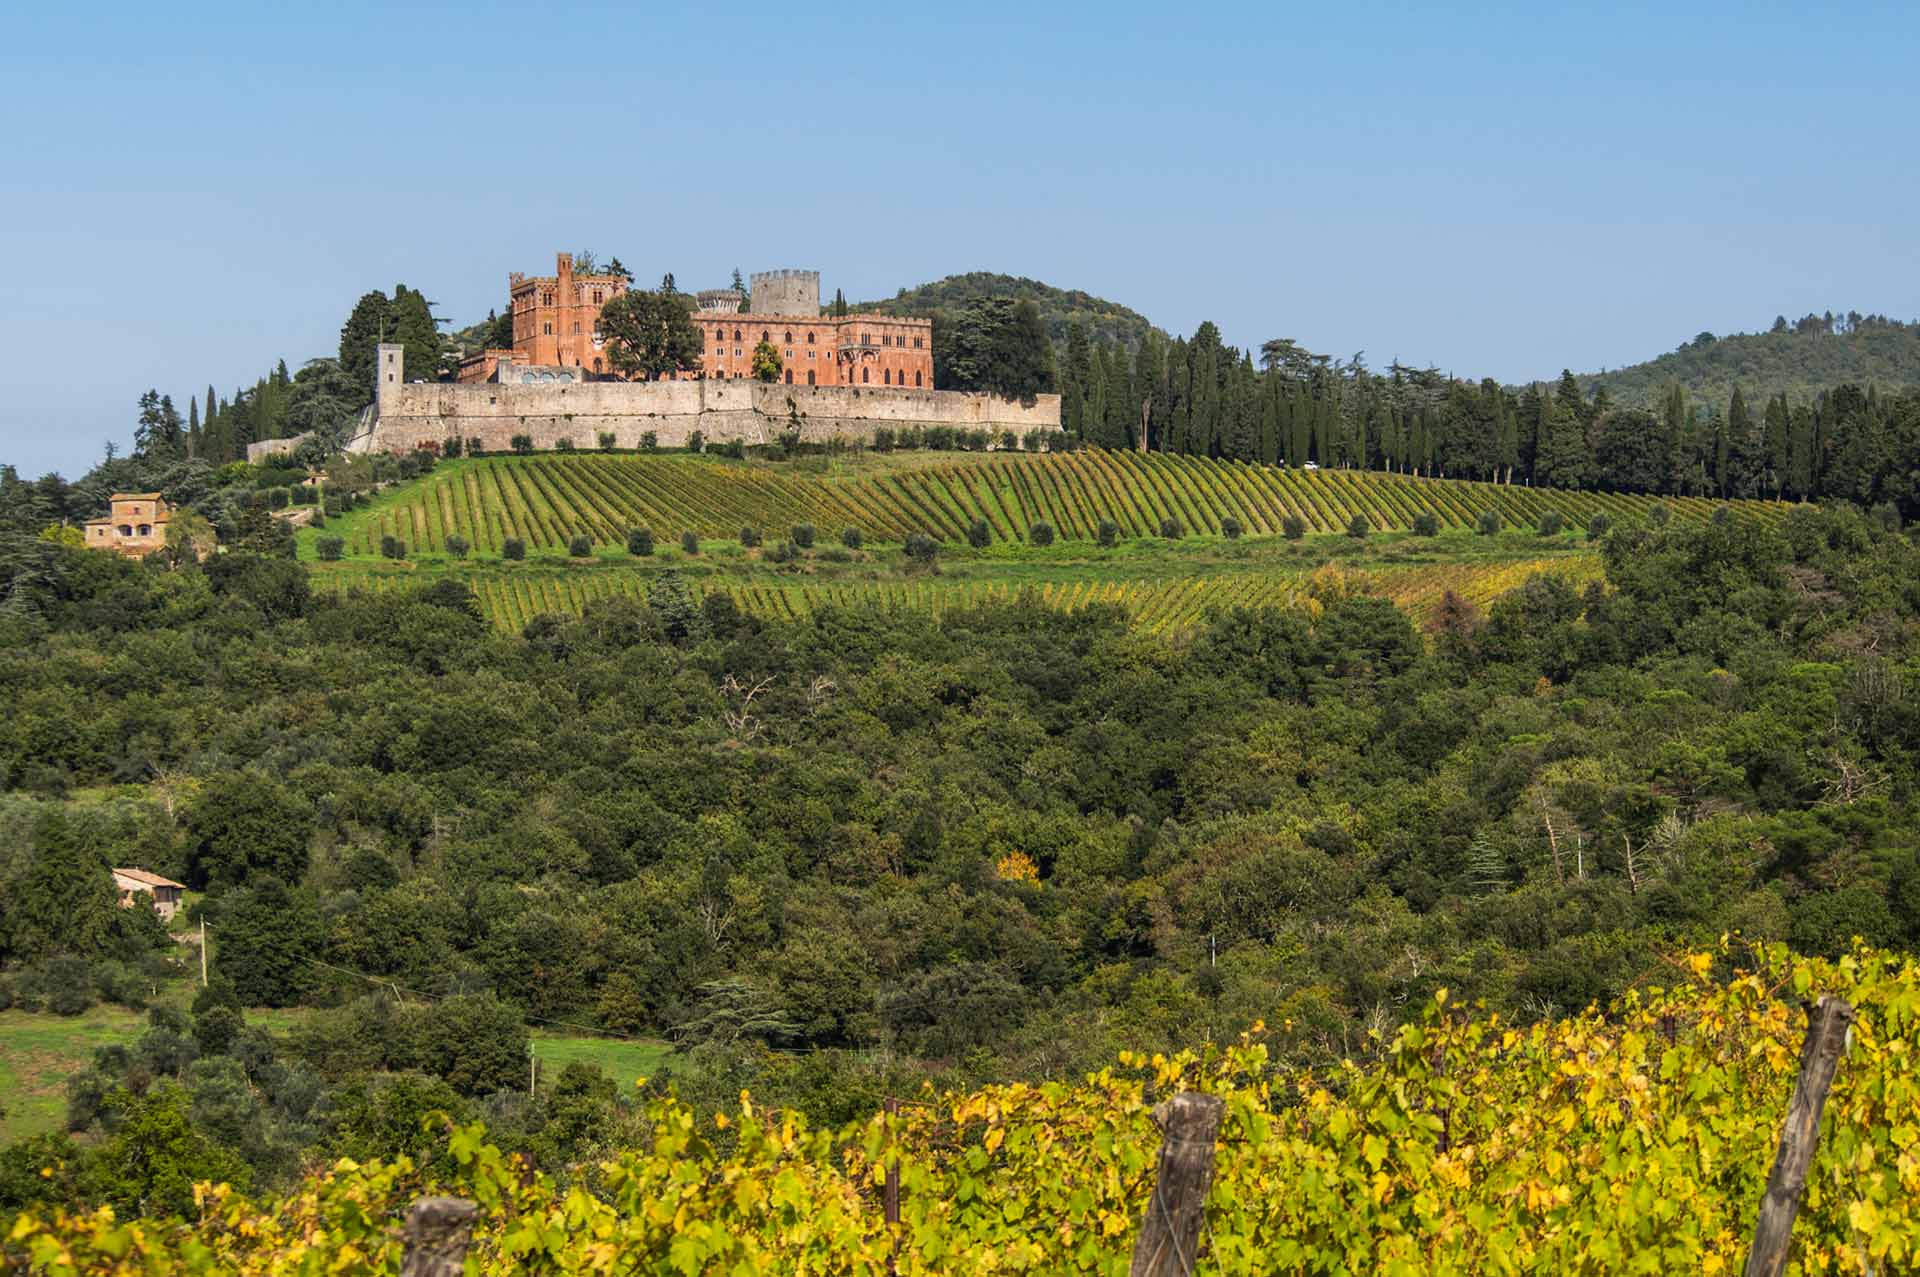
[313,555,1601,636]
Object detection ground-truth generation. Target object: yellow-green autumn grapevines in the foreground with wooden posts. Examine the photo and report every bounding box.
[0,941,1920,1277]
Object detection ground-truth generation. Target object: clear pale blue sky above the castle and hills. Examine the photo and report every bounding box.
[0,0,1920,476]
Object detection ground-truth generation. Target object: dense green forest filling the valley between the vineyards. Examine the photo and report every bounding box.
[0,484,1920,1210]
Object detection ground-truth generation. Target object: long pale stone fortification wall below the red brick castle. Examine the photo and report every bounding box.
[357,380,1060,451]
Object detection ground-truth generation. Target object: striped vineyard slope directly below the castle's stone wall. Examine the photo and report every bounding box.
[332,449,1788,557]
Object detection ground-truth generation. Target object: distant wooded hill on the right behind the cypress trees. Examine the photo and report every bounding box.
[1580,315,1920,407]
